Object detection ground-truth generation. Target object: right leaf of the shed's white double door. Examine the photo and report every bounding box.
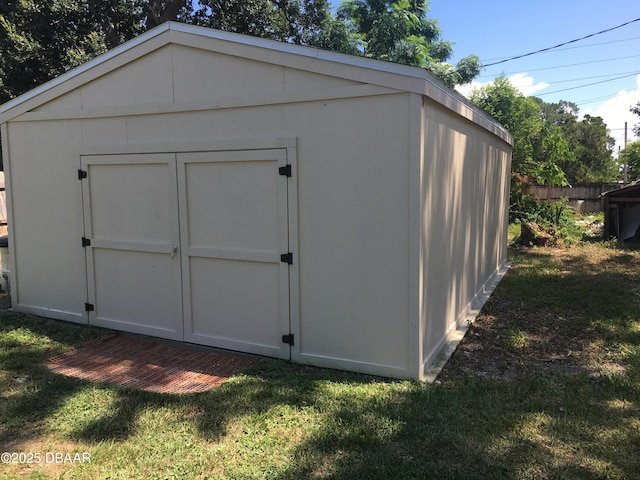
[178,149,290,358]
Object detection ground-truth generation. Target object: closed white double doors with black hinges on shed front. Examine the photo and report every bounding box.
[81,149,292,358]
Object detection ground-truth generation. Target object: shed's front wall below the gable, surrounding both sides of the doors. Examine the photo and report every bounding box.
[5,91,409,377]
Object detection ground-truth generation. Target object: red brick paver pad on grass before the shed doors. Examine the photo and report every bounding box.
[47,336,254,394]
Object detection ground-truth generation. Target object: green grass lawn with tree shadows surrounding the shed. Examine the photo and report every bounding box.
[0,238,640,480]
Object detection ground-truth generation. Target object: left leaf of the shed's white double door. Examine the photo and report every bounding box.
[81,154,183,340]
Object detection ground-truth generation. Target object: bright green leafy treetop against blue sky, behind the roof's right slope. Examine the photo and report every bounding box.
[338,0,480,86]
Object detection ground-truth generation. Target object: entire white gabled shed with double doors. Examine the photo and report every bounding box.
[0,23,511,379]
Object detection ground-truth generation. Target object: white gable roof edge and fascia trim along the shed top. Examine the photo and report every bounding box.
[0,22,512,143]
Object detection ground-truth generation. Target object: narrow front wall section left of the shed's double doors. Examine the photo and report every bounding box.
[3,120,86,321]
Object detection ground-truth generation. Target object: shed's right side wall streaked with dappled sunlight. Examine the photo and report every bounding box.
[420,99,511,371]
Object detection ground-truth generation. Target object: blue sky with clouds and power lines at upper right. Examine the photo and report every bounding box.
[330,0,640,150]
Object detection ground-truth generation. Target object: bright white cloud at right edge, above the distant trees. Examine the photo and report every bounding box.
[580,75,640,154]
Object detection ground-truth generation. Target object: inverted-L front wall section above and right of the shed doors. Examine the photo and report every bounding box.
[117,95,408,376]
